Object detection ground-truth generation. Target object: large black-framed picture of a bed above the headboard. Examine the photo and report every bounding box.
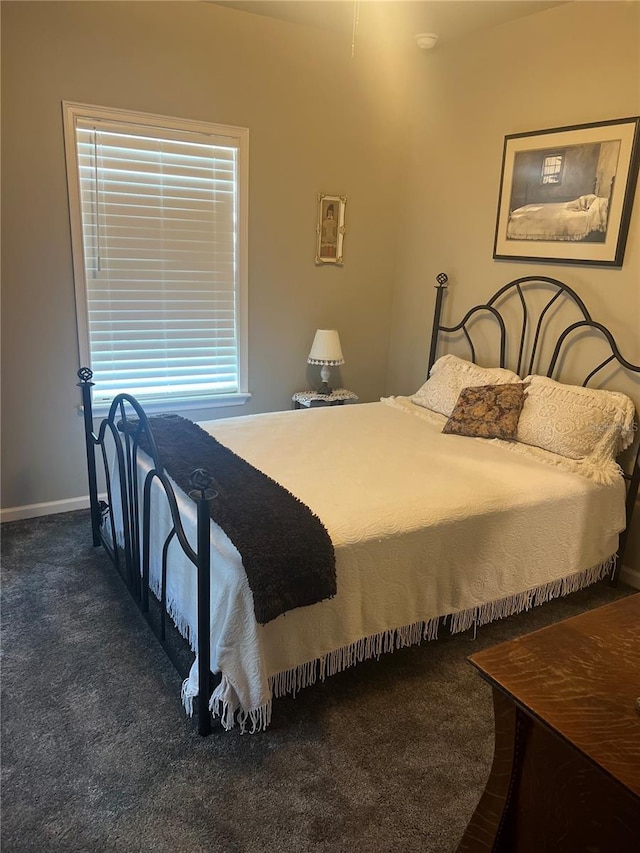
[493,116,640,267]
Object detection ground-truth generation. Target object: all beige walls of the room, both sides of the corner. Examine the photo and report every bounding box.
[2,2,640,564]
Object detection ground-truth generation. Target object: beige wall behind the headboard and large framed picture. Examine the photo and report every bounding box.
[387,2,640,569]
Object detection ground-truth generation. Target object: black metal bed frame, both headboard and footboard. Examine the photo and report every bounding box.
[77,273,640,735]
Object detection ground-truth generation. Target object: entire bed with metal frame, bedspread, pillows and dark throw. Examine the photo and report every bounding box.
[78,275,640,734]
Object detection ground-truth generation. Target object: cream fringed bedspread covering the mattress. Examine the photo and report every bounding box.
[136,398,624,730]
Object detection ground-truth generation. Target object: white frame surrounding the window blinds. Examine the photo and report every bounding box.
[62,101,251,413]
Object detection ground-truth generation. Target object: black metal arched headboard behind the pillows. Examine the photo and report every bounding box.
[427,273,640,584]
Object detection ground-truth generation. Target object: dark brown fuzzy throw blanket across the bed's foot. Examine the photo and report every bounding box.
[122,415,336,625]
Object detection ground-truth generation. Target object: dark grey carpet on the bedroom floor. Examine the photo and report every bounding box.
[1,512,633,853]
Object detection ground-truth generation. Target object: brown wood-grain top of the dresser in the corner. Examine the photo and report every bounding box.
[470,593,640,797]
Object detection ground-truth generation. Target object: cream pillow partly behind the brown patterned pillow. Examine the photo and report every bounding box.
[411,355,520,417]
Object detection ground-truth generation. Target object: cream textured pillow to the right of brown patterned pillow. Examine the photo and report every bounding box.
[517,376,635,459]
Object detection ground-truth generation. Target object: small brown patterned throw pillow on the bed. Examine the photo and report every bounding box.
[442,382,524,441]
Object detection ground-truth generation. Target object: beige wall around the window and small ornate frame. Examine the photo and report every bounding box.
[2,2,408,508]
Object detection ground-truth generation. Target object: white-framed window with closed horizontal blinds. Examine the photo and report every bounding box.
[64,103,248,408]
